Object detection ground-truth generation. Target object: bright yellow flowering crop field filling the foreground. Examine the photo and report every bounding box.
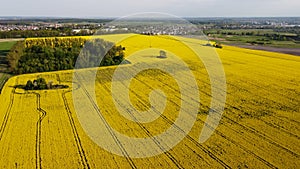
[0,35,300,168]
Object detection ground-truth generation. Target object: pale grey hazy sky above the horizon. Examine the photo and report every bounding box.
[0,0,300,17]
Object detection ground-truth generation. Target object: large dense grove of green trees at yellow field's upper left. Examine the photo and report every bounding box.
[7,37,125,74]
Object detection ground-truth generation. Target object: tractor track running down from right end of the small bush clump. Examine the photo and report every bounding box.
[62,90,91,169]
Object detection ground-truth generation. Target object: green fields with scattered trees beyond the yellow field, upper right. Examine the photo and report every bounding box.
[207,29,300,53]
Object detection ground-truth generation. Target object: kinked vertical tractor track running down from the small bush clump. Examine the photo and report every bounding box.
[32,92,47,169]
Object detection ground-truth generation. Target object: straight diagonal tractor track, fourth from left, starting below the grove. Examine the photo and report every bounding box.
[74,72,137,169]
